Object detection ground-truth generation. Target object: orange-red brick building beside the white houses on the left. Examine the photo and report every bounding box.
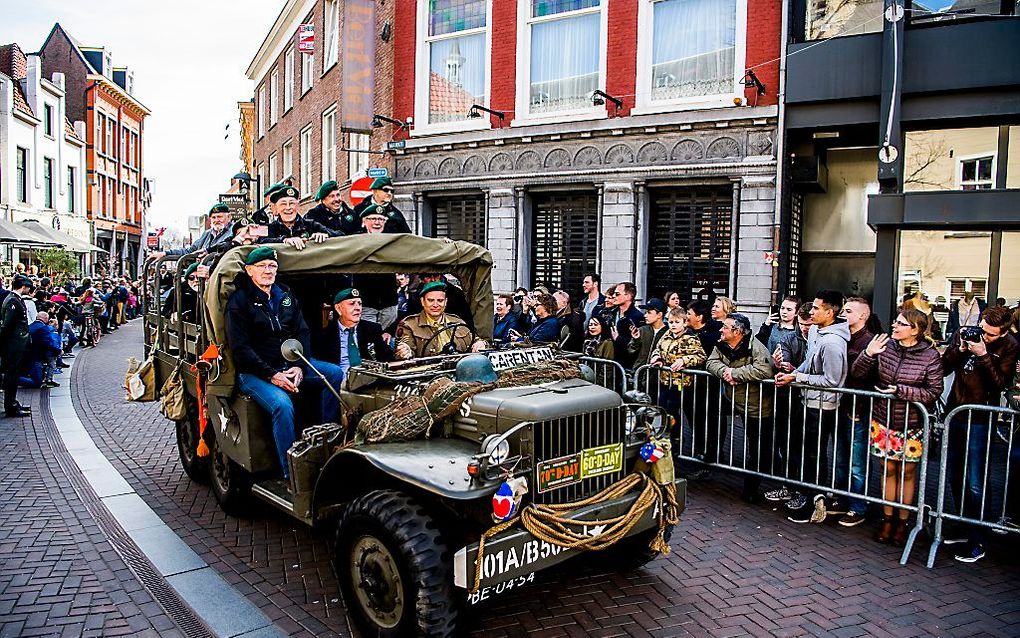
[39,23,149,276]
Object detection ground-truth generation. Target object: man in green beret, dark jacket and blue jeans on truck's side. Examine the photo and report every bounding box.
[226,246,344,479]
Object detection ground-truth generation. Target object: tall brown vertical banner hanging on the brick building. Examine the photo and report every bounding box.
[340,0,375,131]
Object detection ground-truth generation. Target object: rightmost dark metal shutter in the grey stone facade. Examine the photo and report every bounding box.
[648,186,733,301]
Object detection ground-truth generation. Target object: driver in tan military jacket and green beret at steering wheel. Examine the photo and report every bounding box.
[397,282,486,359]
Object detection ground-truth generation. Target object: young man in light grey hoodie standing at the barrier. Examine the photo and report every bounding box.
[775,290,850,523]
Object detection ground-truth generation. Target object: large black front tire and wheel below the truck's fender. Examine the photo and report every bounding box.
[333,490,461,638]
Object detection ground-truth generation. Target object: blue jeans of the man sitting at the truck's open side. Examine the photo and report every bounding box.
[238,359,344,479]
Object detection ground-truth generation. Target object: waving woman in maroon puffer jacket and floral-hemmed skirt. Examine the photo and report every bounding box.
[853,308,942,547]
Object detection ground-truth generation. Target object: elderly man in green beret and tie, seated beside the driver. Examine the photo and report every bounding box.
[317,288,394,377]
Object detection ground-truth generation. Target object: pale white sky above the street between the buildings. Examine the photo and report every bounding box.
[0,0,285,230]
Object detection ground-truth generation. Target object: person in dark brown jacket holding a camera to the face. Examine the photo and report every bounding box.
[942,306,1020,562]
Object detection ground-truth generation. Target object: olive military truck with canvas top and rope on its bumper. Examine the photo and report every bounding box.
[143,235,685,636]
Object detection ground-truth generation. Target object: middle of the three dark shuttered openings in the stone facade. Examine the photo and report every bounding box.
[531,193,599,297]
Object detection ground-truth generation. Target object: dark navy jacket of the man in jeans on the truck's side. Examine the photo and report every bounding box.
[226,273,311,381]
